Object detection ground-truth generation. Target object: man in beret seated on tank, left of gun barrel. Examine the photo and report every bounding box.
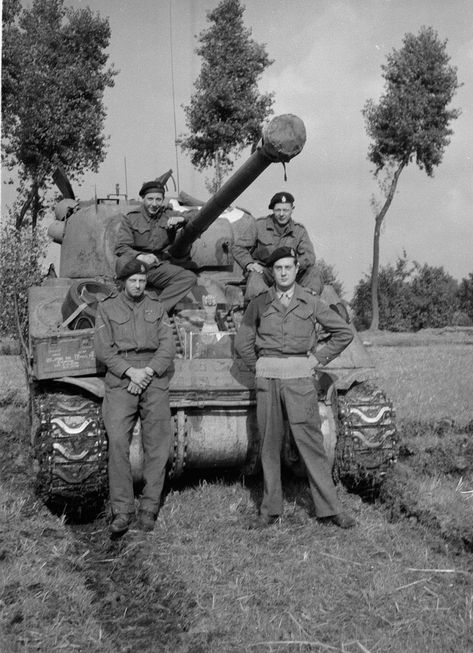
[115,181,197,312]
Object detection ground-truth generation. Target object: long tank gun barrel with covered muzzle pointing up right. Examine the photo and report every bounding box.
[169,114,306,258]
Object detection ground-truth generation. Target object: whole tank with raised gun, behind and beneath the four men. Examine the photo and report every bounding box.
[29,114,397,508]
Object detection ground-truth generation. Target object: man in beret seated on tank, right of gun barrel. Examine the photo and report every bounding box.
[232,193,323,300]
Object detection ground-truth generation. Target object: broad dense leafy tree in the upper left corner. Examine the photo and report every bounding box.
[2,0,116,228]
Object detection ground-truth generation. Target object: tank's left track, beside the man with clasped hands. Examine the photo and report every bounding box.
[34,391,108,506]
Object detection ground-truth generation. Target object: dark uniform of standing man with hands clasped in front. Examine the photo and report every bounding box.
[95,292,175,514]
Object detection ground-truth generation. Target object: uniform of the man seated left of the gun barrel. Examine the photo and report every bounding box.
[115,205,197,311]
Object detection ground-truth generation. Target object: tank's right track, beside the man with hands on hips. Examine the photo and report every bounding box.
[335,382,399,486]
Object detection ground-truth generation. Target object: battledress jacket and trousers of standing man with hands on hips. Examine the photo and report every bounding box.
[235,284,353,517]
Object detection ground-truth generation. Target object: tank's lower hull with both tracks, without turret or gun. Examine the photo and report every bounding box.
[30,275,398,504]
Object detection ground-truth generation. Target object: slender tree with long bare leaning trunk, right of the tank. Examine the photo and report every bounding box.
[363,27,460,329]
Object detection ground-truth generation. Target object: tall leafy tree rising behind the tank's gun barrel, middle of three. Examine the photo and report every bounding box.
[179,0,273,191]
